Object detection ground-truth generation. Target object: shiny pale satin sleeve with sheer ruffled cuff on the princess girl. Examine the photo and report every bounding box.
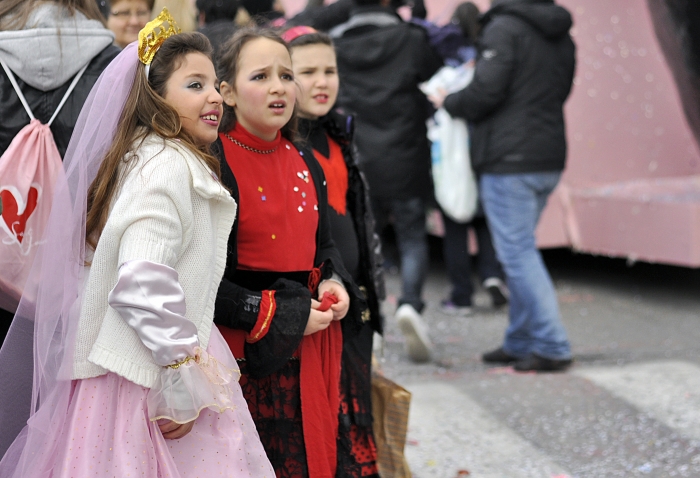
[108,260,240,423]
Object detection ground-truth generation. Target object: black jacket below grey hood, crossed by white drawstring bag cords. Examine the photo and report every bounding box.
[0,45,120,157]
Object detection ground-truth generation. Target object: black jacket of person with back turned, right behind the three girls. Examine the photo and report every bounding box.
[331,6,442,199]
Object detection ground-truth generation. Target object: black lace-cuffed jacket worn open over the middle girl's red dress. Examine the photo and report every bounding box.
[212,139,367,378]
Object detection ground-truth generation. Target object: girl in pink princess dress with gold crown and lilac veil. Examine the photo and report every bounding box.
[0,10,274,478]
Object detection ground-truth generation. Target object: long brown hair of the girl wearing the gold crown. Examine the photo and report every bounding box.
[85,32,221,249]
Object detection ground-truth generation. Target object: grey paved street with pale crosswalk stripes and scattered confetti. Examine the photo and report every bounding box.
[374,251,700,478]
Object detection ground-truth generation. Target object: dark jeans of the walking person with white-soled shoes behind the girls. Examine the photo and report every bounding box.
[371,197,429,312]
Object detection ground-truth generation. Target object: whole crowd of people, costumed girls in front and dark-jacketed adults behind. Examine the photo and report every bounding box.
[0,0,574,478]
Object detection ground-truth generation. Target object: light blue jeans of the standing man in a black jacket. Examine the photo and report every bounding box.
[480,172,571,360]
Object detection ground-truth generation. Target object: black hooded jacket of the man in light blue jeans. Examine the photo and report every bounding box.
[444,0,575,174]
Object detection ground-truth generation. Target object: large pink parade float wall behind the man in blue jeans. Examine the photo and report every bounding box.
[285,0,700,267]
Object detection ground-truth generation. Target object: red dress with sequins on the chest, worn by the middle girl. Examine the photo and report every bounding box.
[217,125,342,478]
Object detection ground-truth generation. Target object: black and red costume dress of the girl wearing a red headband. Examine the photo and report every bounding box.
[299,111,384,477]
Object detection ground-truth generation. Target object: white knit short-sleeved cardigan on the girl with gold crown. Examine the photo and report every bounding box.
[73,135,236,388]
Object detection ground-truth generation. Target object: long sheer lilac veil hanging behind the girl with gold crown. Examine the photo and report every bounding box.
[0,42,139,478]
